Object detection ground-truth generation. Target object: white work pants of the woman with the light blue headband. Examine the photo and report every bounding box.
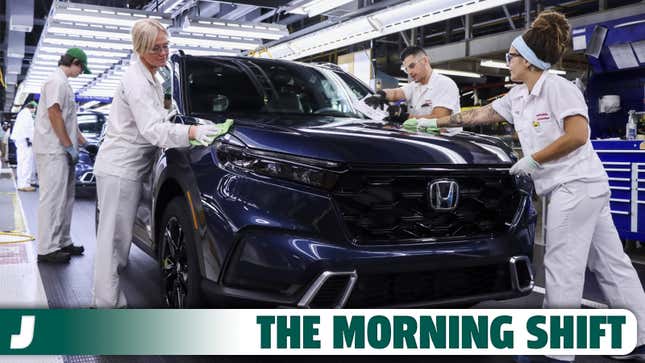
[544,182,645,360]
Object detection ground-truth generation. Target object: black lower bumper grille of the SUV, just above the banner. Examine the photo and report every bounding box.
[345,263,512,308]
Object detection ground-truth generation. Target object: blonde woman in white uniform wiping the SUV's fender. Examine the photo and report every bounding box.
[92,19,231,308]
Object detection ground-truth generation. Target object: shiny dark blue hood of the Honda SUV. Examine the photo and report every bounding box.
[190,115,513,165]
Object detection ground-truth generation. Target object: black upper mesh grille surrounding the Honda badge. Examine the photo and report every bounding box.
[333,170,521,245]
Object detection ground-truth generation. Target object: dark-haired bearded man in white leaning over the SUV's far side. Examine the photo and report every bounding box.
[365,46,459,128]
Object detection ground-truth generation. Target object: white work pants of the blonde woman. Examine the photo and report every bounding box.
[92,175,141,308]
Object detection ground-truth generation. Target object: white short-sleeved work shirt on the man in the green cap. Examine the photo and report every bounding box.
[34,67,78,154]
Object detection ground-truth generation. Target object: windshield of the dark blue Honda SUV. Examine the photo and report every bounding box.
[186,58,369,118]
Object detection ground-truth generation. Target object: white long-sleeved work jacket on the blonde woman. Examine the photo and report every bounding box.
[94,60,190,181]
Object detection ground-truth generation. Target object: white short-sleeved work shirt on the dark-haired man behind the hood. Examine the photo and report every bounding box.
[401,70,460,116]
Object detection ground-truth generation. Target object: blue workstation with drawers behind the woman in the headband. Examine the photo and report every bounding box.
[573,14,645,241]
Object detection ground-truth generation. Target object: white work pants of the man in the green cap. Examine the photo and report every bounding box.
[36,154,75,255]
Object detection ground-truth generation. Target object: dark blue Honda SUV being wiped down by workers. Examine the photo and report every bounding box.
[117,55,535,308]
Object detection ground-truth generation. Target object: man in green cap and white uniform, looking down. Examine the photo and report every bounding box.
[33,48,90,263]
